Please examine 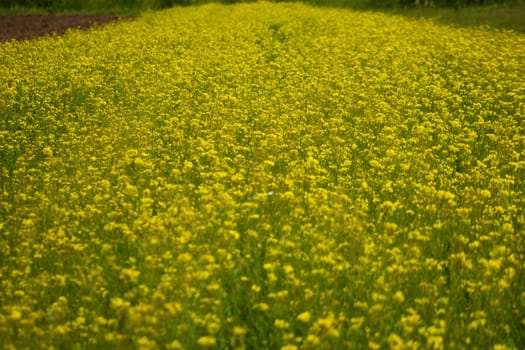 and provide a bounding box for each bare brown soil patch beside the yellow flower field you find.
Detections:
[0,14,133,42]
